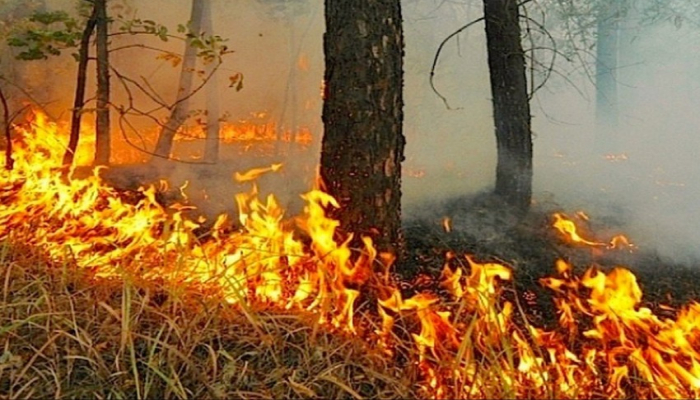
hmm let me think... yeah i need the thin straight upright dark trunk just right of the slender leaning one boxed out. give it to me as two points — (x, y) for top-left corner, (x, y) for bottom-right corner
(94, 0), (111, 165)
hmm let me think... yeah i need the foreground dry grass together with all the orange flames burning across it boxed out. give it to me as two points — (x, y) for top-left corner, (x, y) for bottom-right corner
(0, 113), (700, 398)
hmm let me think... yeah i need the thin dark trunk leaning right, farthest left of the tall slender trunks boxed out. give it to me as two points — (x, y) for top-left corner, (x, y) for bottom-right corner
(63, 8), (97, 167)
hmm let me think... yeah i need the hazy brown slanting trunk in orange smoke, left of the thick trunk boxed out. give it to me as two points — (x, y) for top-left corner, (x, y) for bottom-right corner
(151, 0), (204, 163)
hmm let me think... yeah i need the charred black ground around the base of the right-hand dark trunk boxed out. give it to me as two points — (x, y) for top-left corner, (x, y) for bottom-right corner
(404, 194), (700, 324)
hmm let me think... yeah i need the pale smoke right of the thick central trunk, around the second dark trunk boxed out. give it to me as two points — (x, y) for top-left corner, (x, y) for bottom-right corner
(404, 1), (700, 263)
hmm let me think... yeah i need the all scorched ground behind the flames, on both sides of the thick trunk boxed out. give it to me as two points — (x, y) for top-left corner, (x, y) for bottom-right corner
(89, 159), (700, 325)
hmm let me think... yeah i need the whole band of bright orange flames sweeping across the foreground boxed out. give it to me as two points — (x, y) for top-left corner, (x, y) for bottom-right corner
(0, 115), (700, 398)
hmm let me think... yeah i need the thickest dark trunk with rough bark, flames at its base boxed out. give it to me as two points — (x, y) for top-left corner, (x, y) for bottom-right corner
(320, 0), (405, 255)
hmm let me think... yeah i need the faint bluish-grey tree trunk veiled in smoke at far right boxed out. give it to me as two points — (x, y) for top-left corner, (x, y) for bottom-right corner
(595, 0), (622, 153)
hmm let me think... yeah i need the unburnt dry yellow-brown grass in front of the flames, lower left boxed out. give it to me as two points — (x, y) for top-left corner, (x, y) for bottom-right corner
(0, 244), (416, 399)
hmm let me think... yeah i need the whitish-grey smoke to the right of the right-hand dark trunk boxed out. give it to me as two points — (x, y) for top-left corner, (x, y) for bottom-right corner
(534, 9), (700, 262)
